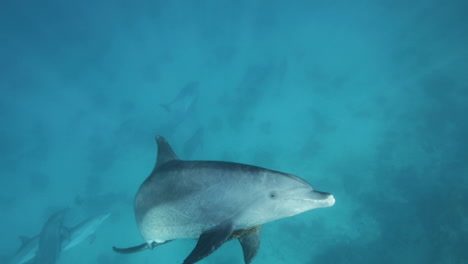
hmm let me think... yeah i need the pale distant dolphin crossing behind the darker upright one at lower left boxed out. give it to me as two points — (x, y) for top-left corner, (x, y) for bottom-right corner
(8, 213), (110, 264)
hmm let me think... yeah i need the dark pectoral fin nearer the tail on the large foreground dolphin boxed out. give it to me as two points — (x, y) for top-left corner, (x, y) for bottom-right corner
(184, 222), (233, 264)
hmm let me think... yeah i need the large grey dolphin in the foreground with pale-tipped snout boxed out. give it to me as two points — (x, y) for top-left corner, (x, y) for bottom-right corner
(113, 136), (335, 264)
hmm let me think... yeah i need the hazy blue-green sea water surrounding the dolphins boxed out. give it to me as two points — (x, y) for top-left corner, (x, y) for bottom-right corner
(0, 0), (468, 264)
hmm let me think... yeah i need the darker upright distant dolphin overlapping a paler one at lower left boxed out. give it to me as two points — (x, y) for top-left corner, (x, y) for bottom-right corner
(33, 210), (67, 264)
